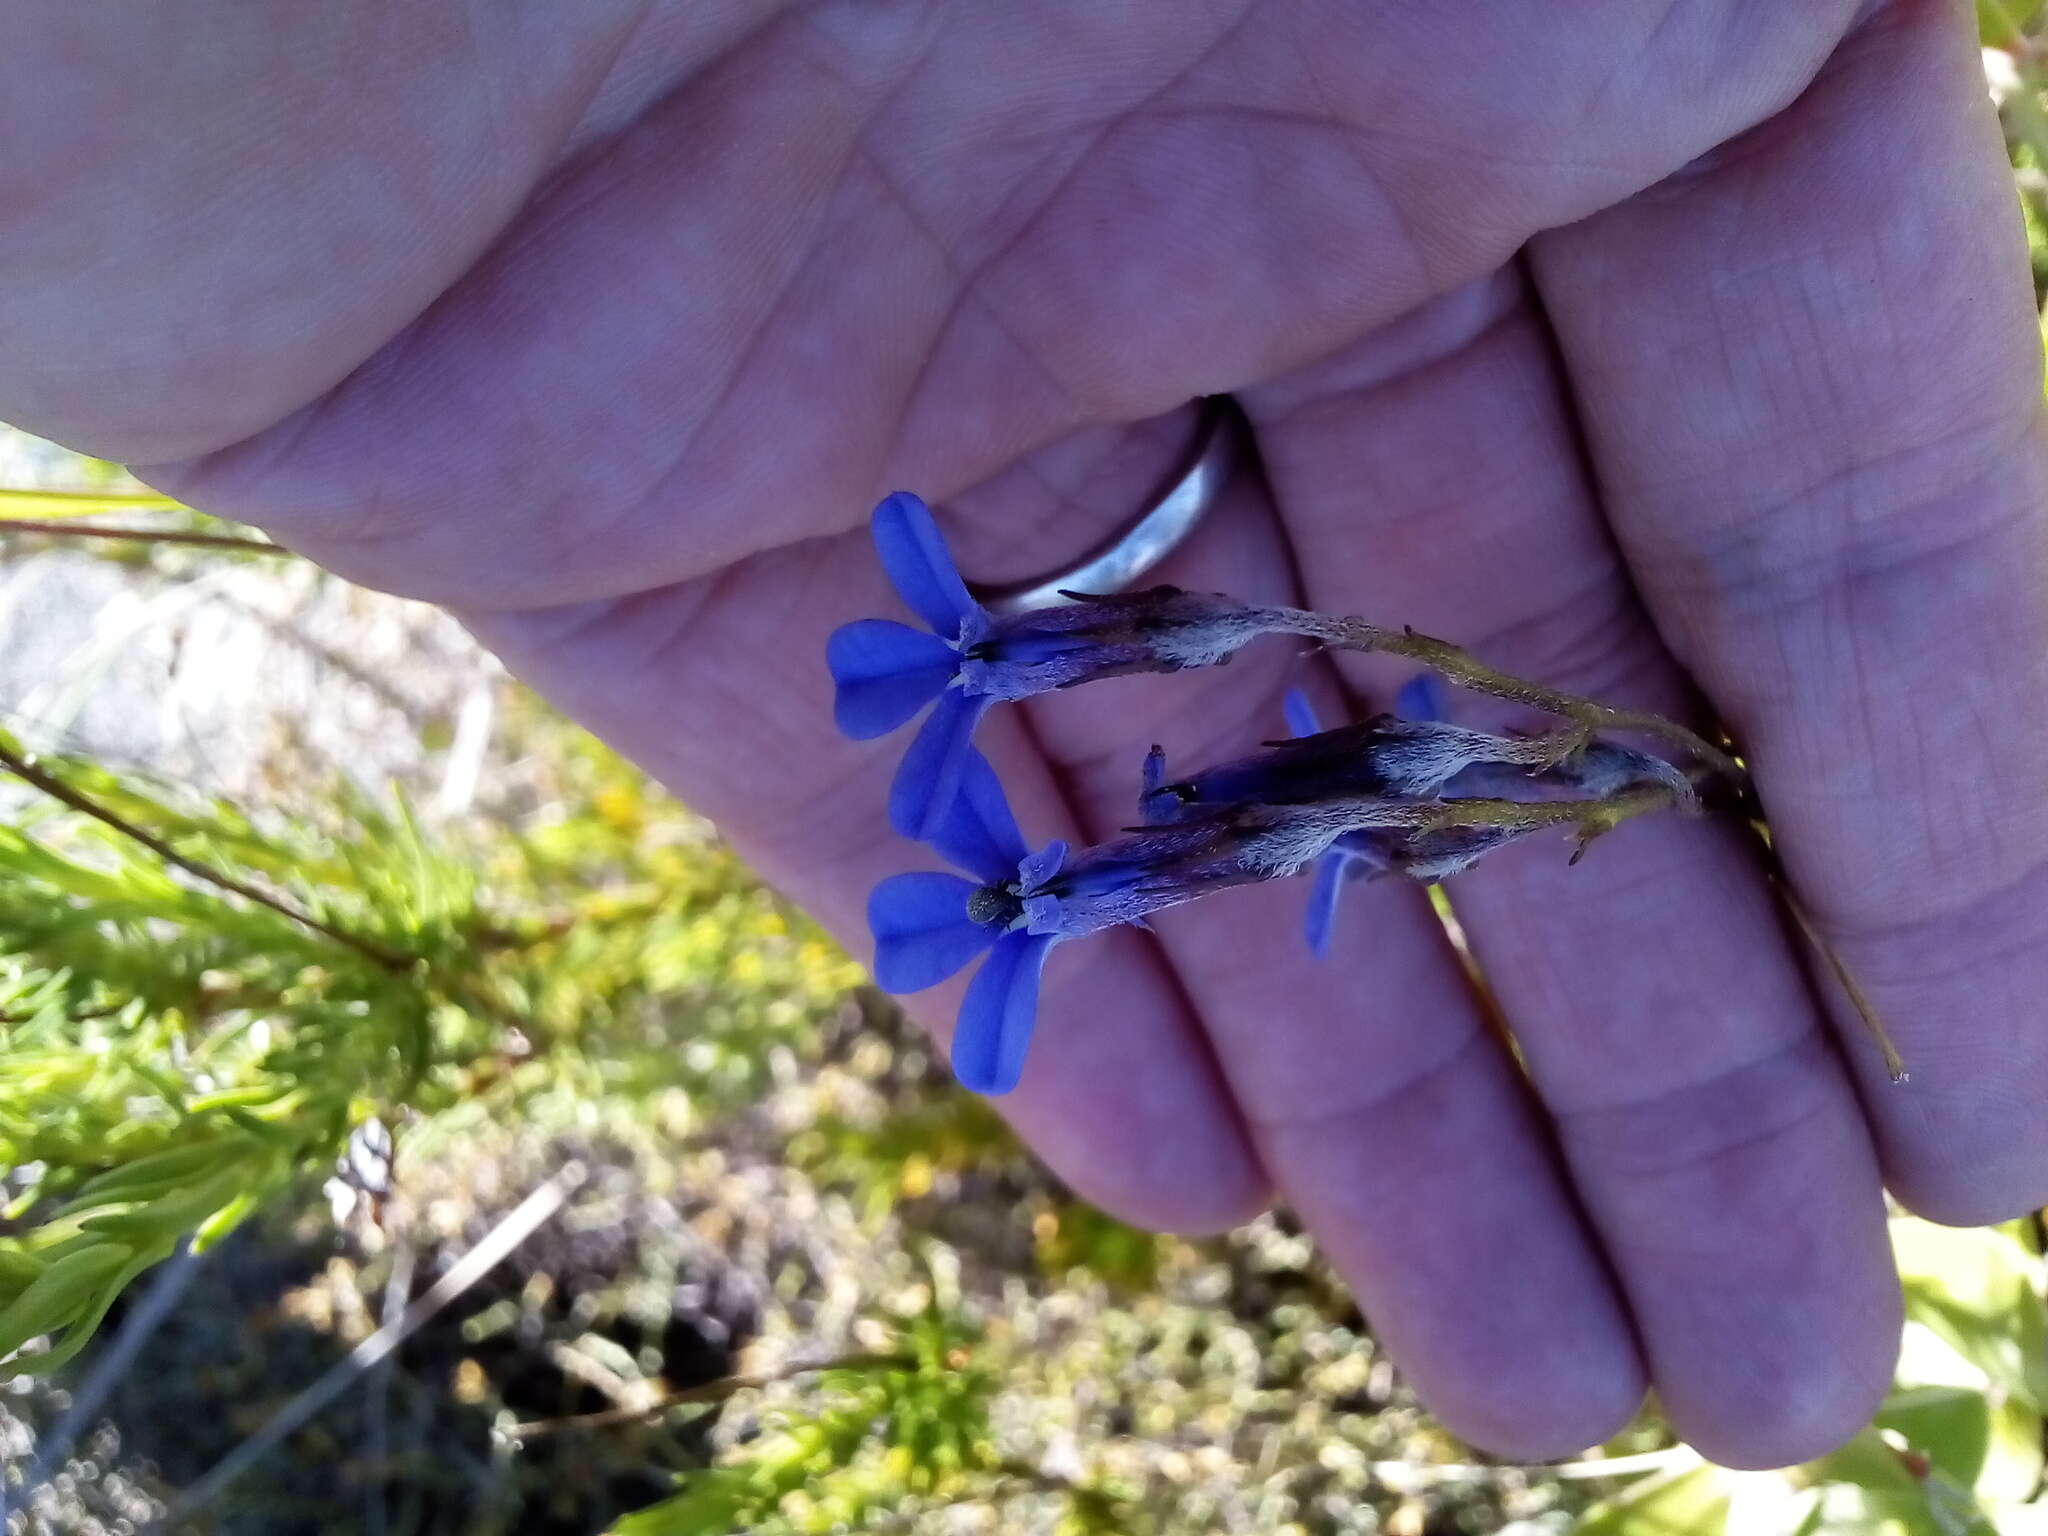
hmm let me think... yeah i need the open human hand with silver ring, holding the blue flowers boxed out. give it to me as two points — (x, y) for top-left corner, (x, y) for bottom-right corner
(0, 0), (2048, 1464)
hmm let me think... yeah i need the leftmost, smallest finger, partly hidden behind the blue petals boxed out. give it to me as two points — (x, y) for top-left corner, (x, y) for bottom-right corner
(469, 481), (1266, 1231)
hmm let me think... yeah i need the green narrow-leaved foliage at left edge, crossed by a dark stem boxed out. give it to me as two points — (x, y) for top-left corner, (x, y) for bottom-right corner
(0, 735), (485, 1374)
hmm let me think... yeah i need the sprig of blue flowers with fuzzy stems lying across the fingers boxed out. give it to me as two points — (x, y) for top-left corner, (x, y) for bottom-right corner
(825, 492), (1903, 1094)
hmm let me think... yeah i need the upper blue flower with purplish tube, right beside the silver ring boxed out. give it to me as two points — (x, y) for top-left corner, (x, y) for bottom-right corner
(825, 492), (1264, 840)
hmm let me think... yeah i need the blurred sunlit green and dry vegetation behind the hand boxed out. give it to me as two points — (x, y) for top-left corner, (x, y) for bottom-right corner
(0, 15), (2048, 1536)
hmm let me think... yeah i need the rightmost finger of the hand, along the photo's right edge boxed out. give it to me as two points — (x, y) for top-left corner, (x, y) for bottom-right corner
(1536, 4), (2048, 1223)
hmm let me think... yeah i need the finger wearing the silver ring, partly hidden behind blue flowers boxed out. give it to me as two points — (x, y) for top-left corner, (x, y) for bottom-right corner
(978, 409), (1642, 1456)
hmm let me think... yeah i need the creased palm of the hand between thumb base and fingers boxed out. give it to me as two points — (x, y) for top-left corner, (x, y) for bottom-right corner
(140, 0), (1853, 608)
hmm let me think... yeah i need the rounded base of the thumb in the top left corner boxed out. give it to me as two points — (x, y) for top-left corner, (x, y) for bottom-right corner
(0, 6), (647, 459)
